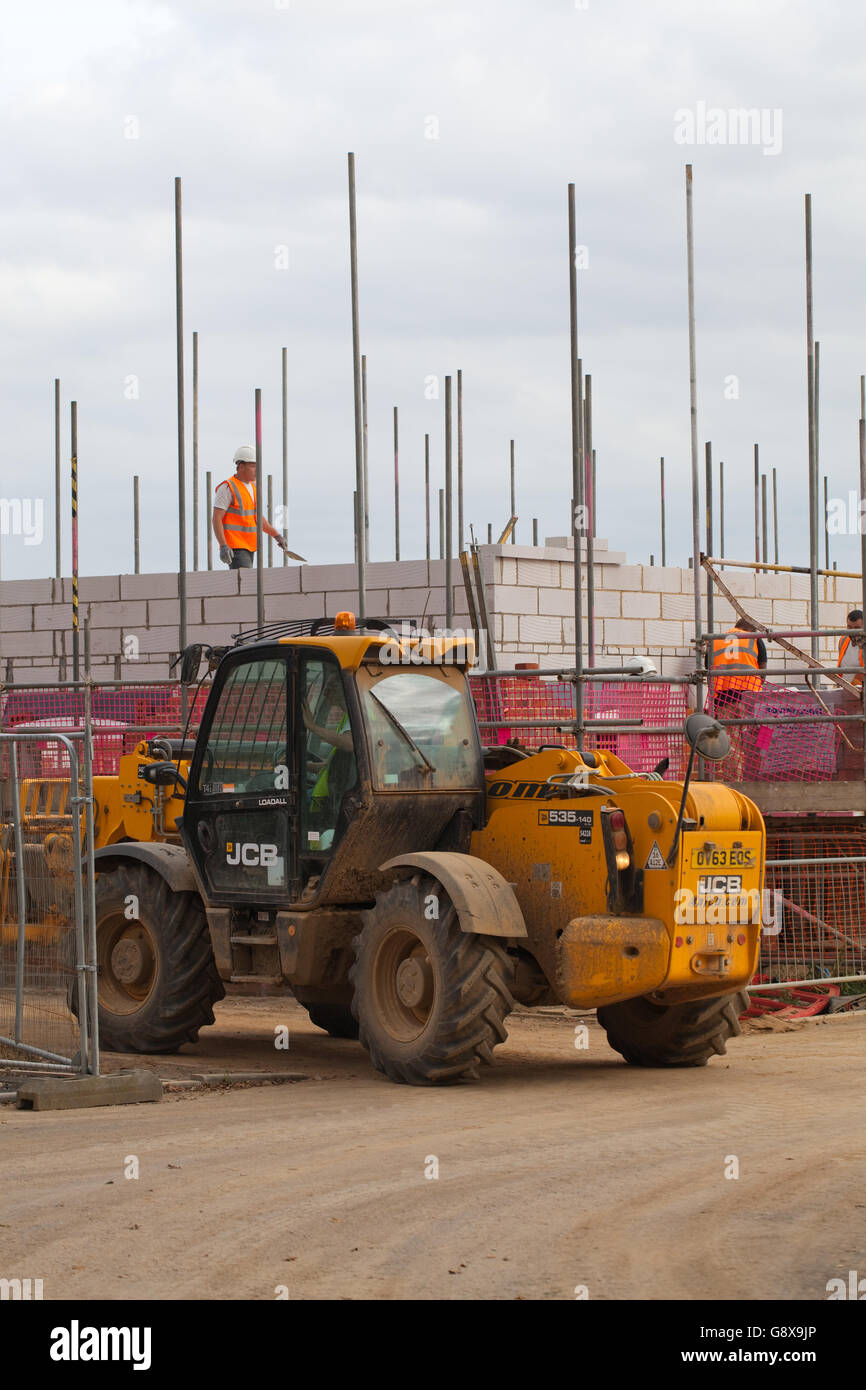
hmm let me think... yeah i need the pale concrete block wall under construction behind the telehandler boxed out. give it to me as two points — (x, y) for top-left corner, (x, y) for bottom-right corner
(0, 537), (862, 682)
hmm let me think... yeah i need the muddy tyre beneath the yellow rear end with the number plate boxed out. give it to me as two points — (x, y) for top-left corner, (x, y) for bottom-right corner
(598, 994), (748, 1066)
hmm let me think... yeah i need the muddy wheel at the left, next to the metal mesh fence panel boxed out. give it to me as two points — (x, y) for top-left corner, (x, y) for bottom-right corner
(70, 863), (225, 1052)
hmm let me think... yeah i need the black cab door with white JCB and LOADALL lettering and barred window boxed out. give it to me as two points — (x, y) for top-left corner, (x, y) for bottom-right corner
(182, 649), (297, 908)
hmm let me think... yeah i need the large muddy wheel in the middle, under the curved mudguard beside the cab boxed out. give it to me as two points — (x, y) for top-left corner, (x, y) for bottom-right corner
(350, 876), (514, 1086)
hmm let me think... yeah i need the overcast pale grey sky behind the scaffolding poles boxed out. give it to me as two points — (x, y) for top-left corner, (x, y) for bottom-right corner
(0, 0), (866, 578)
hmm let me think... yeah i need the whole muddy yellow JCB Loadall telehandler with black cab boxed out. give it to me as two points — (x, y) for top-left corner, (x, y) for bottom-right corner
(13, 614), (765, 1084)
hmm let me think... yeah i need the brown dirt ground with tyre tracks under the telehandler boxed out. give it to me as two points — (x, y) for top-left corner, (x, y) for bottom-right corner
(0, 998), (866, 1300)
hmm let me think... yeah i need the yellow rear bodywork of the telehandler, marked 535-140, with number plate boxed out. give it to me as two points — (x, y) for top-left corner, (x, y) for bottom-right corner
(470, 749), (765, 1008)
